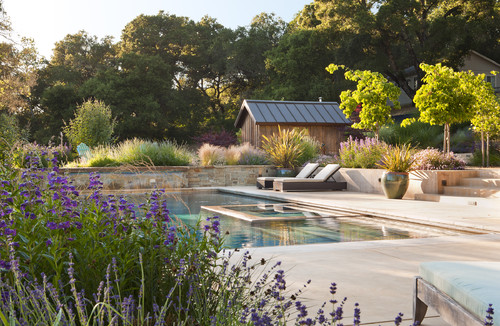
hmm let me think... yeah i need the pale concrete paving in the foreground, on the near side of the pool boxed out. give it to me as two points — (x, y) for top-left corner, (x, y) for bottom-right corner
(240, 234), (500, 325)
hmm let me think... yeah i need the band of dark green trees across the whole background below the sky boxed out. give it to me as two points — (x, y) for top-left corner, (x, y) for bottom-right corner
(0, 0), (500, 143)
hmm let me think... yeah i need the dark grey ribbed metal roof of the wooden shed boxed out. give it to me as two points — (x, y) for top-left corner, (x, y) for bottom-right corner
(234, 100), (351, 128)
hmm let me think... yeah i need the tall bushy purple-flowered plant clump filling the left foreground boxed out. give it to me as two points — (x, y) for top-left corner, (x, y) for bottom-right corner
(0, 153), (222, 318)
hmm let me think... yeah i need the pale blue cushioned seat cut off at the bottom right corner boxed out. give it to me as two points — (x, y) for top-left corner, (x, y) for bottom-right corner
(413, 261), (500, 326)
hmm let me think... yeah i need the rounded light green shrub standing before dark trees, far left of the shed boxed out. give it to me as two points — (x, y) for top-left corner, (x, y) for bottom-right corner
(63, 100), (115, 147)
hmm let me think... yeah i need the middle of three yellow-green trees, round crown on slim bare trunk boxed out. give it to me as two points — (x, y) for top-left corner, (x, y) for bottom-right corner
(402, 63), (478, 153)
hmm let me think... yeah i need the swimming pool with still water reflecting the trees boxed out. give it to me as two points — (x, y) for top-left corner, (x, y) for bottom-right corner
(128, 191), (464, 248)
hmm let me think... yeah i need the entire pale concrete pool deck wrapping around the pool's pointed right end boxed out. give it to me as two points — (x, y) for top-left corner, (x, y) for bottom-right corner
(221, 186), (500, 326)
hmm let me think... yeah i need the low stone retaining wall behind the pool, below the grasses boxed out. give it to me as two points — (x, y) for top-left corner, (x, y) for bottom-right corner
(61, 165), (276, 190)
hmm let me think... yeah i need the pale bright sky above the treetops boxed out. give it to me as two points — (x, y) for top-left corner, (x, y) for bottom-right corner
(3, 0), (312, 58)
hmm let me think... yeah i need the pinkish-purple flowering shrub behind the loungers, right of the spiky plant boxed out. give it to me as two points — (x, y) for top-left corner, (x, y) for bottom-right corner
(338, 137), (388, 169)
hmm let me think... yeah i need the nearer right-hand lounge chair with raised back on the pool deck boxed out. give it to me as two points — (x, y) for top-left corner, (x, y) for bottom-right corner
(273, 164), (347, 192)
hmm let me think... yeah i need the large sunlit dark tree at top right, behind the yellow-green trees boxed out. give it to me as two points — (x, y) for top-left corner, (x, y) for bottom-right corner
(293, 0), (500, 98)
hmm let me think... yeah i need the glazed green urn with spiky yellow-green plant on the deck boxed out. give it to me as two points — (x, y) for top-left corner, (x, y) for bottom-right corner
(377, 144), (415, 199)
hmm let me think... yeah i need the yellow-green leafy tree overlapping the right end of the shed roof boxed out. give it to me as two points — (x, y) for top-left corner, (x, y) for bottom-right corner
(326, 64), (401, 140)
